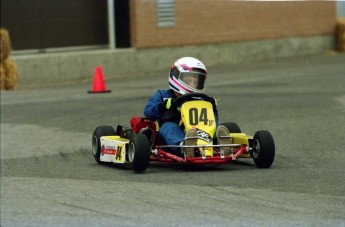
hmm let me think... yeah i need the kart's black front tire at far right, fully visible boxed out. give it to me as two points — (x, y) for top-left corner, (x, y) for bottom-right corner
(251, 130), (275, 168)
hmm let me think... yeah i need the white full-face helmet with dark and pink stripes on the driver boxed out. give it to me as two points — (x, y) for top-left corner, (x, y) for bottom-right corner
(169, 57), (207, 95)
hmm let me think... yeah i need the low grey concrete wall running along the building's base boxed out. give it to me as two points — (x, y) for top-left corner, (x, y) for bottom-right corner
(13, 35), (335, 86)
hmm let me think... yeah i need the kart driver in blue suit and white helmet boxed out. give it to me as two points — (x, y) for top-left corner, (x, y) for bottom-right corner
(144, 57), (230, 157)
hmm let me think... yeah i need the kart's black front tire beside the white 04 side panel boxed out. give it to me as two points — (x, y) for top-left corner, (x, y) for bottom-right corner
(128, 133), (151, 172)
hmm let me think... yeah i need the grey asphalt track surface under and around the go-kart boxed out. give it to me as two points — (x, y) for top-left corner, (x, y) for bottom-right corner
(1, 54), (345, 226)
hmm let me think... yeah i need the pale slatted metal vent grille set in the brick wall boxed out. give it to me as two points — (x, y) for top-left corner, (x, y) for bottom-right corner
(156, 0), (175, 28)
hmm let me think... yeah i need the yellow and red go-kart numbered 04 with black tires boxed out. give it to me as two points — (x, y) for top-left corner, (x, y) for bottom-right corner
(92, 93), (275, 172)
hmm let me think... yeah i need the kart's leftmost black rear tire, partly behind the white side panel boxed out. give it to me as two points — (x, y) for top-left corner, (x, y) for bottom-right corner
(92, 126), (116, 164)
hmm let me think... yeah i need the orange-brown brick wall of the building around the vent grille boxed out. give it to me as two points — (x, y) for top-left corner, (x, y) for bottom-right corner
(130, 0), (336, 48)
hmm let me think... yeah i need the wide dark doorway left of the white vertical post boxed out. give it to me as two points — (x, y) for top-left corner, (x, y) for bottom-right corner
(1, 0), (107, 50)
